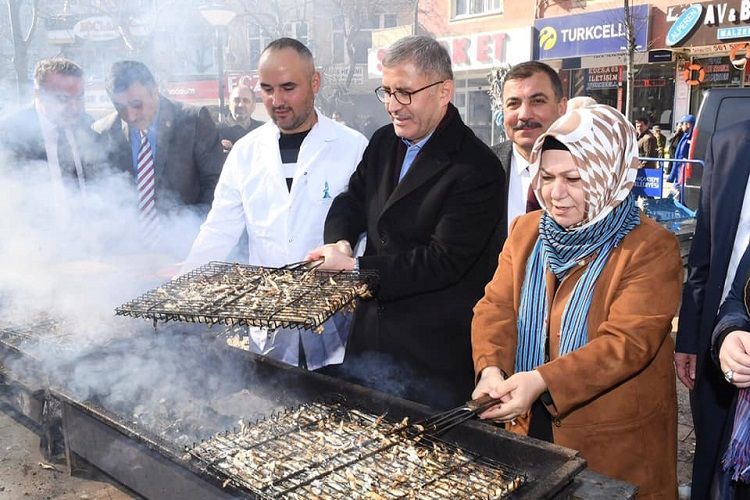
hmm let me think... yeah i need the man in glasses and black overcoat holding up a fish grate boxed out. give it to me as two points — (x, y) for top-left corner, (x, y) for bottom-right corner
(310, 36), (505, 407)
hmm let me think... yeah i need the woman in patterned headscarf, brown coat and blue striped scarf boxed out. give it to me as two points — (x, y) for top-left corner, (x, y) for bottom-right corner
(472, 105), (682, 498)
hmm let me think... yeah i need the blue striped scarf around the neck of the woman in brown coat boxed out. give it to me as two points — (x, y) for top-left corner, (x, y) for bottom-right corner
(515, 194), (640, 373)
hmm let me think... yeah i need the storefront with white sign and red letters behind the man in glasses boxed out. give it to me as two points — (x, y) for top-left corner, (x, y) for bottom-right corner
(368, 27), (533, 144)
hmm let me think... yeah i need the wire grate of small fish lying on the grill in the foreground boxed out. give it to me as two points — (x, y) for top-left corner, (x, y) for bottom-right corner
(188, 403), (526, 500)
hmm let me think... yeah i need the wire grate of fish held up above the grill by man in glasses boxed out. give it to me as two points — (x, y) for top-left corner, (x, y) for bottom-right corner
(115, 262), (376, 330)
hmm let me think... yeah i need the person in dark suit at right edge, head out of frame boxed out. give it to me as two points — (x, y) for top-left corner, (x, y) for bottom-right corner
(675, 121), (750, 499)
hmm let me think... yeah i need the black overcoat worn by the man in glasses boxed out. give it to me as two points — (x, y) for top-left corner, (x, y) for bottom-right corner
(325, 105), (505, 406)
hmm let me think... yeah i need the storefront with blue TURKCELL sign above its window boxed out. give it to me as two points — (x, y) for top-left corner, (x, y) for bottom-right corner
(535, 5), (675, 123)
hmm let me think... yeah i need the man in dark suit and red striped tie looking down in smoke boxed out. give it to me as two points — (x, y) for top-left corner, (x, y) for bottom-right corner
(93, 61), (224, 211)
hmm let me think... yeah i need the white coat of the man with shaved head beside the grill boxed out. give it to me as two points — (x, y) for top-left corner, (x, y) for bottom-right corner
(181, 110), (367, 370)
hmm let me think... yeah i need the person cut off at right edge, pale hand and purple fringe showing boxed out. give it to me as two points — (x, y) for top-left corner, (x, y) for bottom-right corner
(712, 246), (750, 500)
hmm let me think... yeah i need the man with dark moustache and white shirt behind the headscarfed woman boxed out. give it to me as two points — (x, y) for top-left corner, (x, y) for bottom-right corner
(492, 61), (566, 240)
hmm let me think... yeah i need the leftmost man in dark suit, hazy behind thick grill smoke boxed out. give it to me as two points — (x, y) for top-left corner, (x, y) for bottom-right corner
(0, 58), (102, 201)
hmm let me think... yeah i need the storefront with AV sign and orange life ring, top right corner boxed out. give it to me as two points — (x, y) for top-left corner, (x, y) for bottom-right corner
(655, 0), (750, 115)
